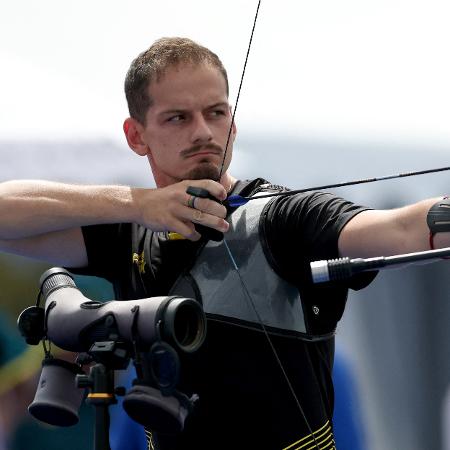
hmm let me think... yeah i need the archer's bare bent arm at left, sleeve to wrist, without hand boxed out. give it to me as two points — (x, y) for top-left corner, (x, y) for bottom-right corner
(0, 180), (142, 267)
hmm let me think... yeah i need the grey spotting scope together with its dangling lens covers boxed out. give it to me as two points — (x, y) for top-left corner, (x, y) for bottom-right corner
(18, 268), (206, 433)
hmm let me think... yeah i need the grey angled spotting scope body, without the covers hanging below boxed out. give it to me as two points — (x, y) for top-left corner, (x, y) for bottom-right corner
(40, 268), (206, 353)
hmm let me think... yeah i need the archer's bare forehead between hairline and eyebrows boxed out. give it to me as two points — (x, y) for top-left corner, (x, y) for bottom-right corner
(148, 63), (228, 109)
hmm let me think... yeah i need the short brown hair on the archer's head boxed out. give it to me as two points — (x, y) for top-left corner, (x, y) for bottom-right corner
(125, 37), (229, 124)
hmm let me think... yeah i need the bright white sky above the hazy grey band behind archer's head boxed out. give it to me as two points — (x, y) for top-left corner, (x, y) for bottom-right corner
(0, 0), (450, 147)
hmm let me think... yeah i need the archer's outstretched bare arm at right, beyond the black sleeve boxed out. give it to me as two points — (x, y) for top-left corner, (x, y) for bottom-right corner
(339, 197), (450, 258)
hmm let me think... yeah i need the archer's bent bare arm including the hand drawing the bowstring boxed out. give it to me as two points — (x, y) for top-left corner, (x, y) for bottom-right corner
(0, 180), (228, 267)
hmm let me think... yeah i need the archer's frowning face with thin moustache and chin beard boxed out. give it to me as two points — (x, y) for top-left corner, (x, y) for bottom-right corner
(142, 64), (236, 187)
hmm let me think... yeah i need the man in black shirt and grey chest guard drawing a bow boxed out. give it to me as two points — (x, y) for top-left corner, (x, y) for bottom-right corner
(0, 38), (450, 449)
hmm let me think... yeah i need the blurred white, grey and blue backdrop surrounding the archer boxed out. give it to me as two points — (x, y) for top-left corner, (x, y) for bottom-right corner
(0, 0), (450, 450)
